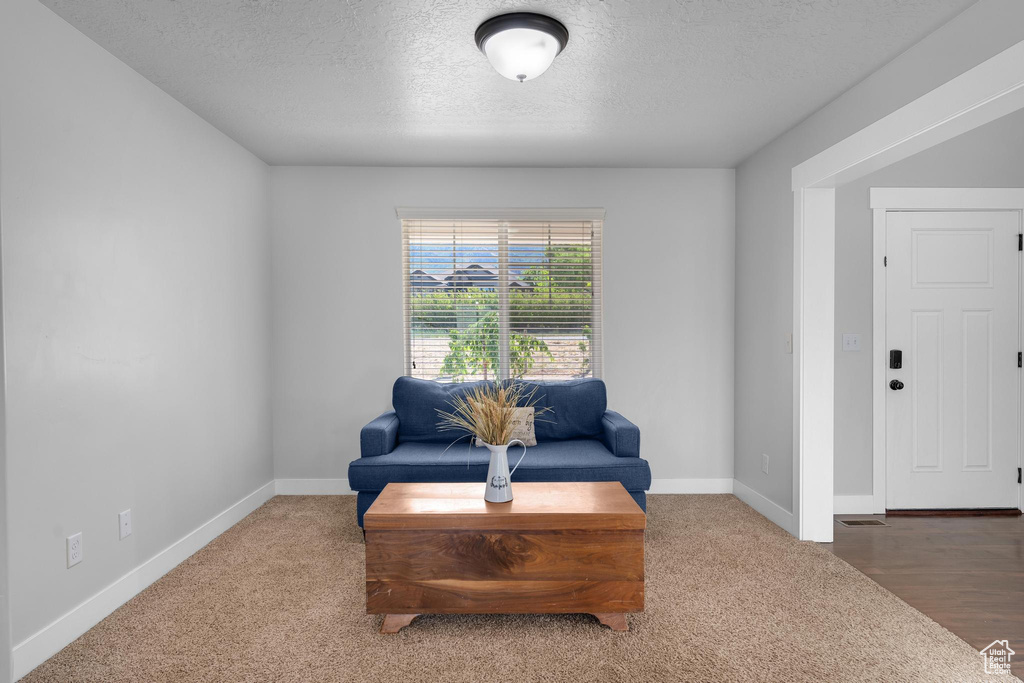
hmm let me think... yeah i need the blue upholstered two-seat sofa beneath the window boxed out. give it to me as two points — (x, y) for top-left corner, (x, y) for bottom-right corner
(348, 377), (650, 526)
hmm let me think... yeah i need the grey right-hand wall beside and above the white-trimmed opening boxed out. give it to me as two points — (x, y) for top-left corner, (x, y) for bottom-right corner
(735, 0), (1024, 510)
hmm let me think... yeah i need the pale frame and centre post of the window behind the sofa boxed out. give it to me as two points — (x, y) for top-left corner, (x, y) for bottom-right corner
(395, 207), (605, 382)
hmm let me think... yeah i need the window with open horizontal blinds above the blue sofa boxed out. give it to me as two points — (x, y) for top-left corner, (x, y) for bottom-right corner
(398, 209), (604, 382)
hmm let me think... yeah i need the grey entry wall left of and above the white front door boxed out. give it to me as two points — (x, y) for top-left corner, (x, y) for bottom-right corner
(836, 111), (1024, 496)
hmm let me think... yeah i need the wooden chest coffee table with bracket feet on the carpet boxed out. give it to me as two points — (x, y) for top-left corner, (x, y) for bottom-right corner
(364, 482), (647, 633)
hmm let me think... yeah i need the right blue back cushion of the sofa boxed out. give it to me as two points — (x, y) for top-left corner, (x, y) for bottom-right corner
(523, 377), (608, 441)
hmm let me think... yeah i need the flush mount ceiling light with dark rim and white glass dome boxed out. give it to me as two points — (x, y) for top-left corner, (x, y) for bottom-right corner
(476, 12), (569, 83)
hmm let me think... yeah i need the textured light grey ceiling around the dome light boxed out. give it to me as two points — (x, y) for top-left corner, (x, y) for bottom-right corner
(43, 0), (973, 167)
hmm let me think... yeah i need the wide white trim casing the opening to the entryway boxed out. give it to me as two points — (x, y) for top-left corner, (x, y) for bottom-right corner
(792, 41), (1024, 543)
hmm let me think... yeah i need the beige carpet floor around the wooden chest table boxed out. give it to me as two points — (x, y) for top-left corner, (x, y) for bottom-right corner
(24, 496), (1010, 683)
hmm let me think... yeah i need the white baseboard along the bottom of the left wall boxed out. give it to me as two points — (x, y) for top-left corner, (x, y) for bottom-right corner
(11, 480), (274, 681)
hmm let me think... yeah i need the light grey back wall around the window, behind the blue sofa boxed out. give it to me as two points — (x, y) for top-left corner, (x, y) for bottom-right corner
(270, 167), (735, 479)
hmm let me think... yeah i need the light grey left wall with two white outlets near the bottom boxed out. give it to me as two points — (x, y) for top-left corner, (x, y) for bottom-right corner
(0, 0), (272, 655)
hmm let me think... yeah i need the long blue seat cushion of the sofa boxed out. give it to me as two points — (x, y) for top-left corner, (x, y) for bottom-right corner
(348, 439), (650, 492)
